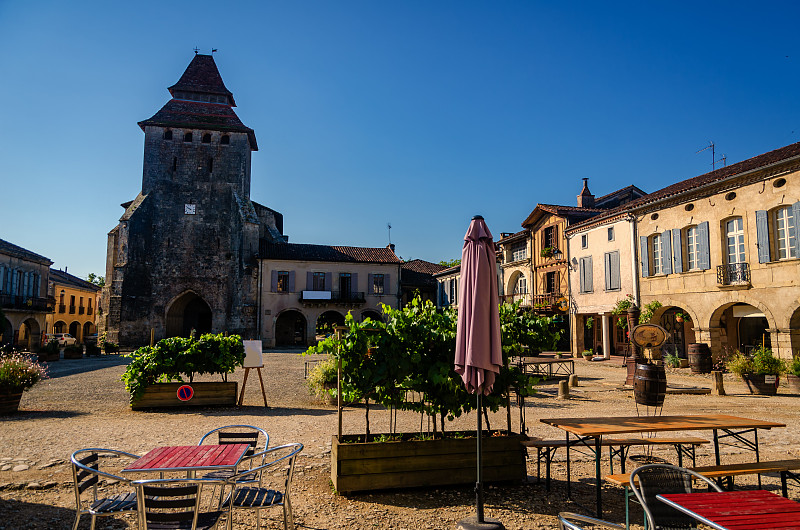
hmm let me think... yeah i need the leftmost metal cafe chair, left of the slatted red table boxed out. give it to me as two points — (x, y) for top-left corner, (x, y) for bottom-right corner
(70, 448), (139, 530)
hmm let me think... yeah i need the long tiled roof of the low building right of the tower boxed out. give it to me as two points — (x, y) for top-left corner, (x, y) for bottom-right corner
(259, 239), (400, 263)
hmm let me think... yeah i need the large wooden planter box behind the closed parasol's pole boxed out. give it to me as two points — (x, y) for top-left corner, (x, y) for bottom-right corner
(331, 434), (527, 493)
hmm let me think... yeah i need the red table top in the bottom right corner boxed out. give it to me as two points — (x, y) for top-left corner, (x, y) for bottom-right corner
(659, 490), (800, 530)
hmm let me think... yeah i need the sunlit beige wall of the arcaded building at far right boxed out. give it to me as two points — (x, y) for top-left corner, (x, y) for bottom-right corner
(637, 169), (800, 358)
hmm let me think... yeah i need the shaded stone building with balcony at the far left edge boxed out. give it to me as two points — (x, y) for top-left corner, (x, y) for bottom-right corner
(0, 239), (53, 351)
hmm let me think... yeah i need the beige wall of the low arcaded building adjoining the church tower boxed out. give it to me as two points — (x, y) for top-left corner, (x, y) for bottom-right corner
(260, 259), (400, 348)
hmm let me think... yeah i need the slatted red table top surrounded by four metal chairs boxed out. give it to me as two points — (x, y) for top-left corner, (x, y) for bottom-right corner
(122, 444), (250, 472)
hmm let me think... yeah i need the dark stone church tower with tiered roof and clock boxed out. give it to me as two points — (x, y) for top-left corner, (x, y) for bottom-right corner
(101, 55), (285, 347)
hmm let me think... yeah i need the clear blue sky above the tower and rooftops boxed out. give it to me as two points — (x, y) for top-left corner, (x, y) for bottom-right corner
(0, 0), (800, 277)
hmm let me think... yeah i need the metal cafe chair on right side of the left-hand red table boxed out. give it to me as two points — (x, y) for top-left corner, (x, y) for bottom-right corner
(222, 443), (303, 530)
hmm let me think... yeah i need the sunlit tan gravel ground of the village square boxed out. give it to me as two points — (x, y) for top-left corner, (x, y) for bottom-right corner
(0, 351), (800, 530)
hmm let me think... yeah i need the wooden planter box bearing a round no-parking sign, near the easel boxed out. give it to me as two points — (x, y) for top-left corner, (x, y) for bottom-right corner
(131, 381), (238, 410)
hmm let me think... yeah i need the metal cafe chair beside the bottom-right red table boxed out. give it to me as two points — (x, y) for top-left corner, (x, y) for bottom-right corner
(630, 464), (722, 530)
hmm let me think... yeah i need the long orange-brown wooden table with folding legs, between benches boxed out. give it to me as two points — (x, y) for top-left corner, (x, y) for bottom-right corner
(540, 414), (786, 519)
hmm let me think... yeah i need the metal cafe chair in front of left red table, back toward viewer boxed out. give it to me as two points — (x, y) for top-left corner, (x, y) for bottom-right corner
(133, 478), (225, 530)
